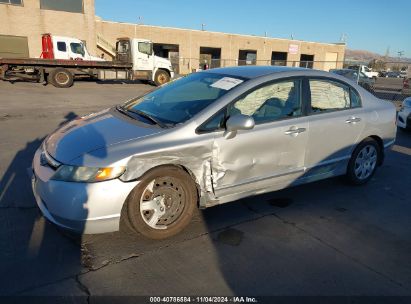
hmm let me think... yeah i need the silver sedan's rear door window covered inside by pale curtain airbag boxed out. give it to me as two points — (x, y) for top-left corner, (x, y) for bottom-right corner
(309, 79), (351, 113)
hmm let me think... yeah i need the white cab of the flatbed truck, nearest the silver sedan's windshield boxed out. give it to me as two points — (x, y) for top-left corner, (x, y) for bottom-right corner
(116, 38), (174, 85)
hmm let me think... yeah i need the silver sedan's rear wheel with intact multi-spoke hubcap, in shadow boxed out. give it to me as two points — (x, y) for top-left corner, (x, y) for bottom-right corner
(346, 138), (382, 185)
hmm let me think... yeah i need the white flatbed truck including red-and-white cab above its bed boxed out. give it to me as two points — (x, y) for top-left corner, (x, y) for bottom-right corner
(0, 34), (174, 88)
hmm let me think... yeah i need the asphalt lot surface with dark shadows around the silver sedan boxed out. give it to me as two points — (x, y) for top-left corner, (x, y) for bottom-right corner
(0, 82), (411, 302)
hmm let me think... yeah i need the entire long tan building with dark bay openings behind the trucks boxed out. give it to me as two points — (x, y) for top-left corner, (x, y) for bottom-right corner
(0, 0), (345, 74)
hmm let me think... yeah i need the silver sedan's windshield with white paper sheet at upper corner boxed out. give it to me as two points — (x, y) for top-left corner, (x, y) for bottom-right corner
(123, 72), (244, 125)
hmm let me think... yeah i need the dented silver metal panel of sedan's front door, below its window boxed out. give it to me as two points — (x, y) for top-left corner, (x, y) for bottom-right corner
(212, 117), (309, 198)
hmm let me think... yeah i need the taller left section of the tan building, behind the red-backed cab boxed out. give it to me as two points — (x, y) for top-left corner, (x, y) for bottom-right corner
(0, 0), (96, 57)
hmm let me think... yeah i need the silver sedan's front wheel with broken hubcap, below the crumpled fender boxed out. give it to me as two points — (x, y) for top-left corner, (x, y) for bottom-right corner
(127, 166), (198, 240)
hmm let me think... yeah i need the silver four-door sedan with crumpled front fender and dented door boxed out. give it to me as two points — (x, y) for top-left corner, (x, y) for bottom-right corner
(32, 66), (396, 239)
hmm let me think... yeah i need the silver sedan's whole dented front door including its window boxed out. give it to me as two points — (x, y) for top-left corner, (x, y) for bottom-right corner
(212, 78), (308, 199)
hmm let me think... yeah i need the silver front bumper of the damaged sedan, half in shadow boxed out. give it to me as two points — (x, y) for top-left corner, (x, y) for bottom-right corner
(32, 150), (138, 234)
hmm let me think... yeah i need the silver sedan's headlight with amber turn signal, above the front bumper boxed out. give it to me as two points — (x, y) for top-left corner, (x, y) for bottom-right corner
(51, 165), (126, 183)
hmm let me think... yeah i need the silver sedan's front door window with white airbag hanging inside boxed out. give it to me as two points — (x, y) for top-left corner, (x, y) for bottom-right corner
(228, 80), (302, 124)
